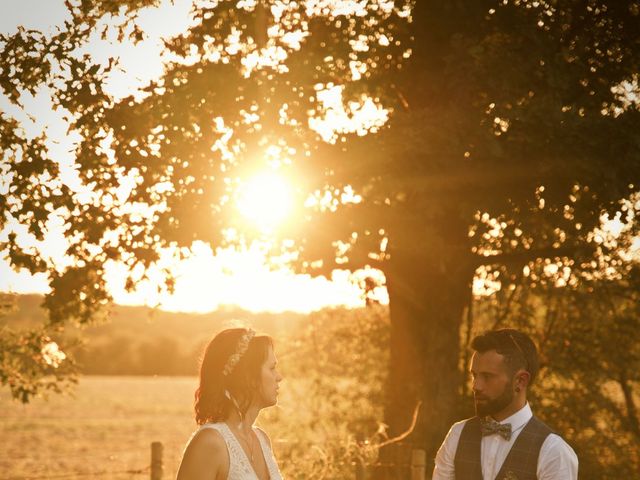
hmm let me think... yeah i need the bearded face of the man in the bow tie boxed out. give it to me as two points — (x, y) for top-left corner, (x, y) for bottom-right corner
(471, 350), (514, 417)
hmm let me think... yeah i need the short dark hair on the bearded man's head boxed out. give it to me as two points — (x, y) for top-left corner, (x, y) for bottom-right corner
(471, 328), (540, 385)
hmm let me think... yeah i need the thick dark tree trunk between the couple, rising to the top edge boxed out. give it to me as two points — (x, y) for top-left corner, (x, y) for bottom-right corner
(382, 0), (502, 469)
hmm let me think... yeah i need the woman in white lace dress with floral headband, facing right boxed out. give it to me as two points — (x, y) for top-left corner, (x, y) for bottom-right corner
(177, 328), (282, 480)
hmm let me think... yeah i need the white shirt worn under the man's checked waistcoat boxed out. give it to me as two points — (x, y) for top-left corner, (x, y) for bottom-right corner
(432, 403), (578, 480)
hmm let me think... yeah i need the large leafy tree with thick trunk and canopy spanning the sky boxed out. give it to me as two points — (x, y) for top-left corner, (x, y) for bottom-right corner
(0, 0), (640, 464)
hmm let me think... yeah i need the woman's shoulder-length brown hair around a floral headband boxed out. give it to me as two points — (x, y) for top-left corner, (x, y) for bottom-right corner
(194, 328), (273, 425)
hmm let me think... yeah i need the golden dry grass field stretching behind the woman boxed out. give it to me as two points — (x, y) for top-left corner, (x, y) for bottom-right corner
(0, 376), (348, 480)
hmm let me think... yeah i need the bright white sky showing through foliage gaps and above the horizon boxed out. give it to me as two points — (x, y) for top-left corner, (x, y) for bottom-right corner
(0, 0), (387, 312)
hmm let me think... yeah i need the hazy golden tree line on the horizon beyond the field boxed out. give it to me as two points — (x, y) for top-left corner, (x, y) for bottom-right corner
(0, 294), (307, 382)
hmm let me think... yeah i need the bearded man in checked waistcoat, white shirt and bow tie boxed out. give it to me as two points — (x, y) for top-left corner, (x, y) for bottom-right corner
(432, 329), (578, 480)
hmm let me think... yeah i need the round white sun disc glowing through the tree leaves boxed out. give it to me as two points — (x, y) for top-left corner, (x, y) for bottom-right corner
(237, 172), (293, 232)
